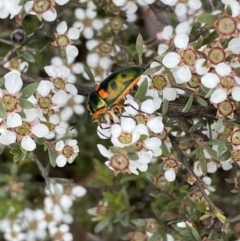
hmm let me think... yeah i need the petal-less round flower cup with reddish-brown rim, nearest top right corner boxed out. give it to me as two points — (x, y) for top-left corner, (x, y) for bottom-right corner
(214, 13), (238, 38)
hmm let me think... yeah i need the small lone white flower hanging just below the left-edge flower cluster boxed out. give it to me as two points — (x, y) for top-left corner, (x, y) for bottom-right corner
(55, 139), (79, 167)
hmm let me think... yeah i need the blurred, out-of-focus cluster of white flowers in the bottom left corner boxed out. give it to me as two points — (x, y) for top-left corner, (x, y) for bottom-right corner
(0, 184), (86, 241)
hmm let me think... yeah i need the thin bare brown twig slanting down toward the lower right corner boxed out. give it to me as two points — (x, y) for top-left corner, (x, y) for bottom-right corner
(168, 133), (218, 211)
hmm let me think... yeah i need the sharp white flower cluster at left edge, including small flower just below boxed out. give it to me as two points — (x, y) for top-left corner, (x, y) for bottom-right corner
(0, 66), (80, 169)
